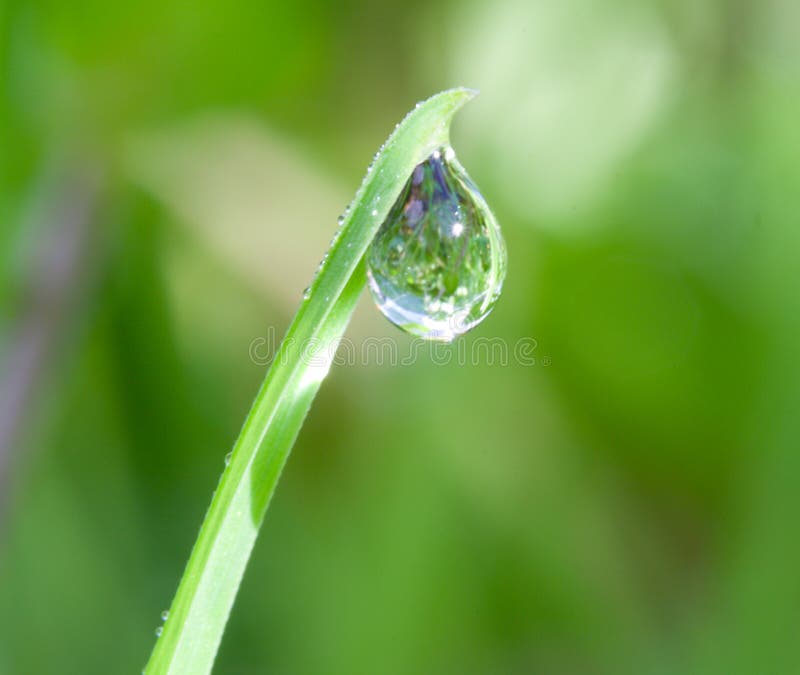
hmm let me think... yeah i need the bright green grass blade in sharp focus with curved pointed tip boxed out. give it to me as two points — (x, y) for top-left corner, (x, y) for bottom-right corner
(145, 89), (475, 675)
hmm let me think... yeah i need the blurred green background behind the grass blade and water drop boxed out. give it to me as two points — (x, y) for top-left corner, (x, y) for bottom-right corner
(0, 0), (800, 675)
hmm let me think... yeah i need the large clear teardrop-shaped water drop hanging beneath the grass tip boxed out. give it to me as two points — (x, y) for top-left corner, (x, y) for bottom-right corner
(367, 148), (506, 342)
